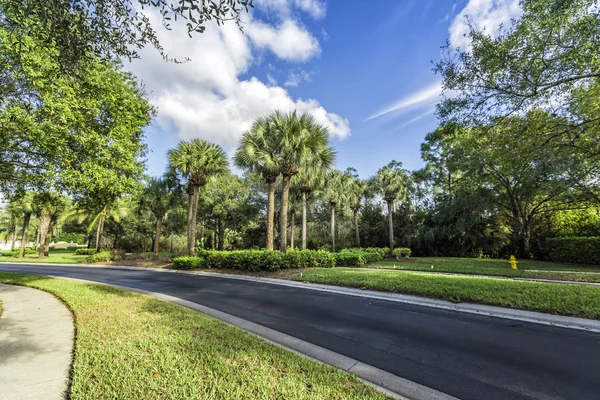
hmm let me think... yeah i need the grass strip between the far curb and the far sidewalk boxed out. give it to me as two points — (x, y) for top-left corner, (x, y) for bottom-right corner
(292, 268), (600, 319)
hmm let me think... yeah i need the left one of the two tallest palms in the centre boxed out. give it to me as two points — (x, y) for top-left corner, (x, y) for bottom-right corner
(233, 118), (279, 250)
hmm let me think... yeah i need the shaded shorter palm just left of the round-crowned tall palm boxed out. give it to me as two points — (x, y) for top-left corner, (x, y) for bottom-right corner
(139, 177), (176, 253)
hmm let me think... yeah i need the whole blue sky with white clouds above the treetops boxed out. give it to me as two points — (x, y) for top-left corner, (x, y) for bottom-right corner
(135, 0), (519, 177)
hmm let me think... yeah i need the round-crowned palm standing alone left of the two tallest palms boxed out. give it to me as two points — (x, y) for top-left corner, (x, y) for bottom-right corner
(168, 139), (227, 255)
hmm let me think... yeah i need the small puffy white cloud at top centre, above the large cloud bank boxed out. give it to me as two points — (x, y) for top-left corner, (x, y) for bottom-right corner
(244, 19), (321, 61)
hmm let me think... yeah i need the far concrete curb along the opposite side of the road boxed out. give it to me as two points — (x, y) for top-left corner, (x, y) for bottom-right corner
(0, 263), (600, 333)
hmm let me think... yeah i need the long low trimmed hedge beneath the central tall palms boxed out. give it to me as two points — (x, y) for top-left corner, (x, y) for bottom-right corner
(173, 250), (336, 271)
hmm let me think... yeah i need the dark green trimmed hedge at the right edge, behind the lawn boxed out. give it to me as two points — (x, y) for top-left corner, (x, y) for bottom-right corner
(546, 236), (600, 265)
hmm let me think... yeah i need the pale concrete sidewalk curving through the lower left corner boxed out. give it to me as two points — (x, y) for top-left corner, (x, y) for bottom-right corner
(0, 284), (74, 400)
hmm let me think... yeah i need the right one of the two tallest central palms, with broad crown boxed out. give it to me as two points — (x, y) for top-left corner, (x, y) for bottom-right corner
(270, 111), (335, 253)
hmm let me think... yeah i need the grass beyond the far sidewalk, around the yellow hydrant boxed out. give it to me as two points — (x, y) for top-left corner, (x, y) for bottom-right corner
(368, 257), (600, 283)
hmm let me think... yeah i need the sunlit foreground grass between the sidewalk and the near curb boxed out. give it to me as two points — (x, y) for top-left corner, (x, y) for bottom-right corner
(0, 273), (385, 400)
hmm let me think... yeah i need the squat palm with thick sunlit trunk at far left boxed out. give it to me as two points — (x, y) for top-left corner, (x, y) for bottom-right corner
(33, 191), (70, 258)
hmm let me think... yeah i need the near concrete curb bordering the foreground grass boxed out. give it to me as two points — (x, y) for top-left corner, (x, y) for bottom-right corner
(57, 275), (459, 400)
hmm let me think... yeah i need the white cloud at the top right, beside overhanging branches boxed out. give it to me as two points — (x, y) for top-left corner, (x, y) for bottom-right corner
(450, 0), (522, 50)
